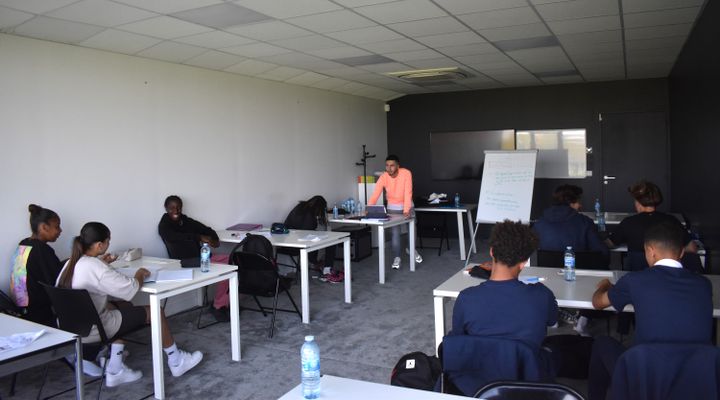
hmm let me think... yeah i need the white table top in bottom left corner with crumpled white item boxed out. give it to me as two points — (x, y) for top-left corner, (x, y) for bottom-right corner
(0, 314), (77, 363)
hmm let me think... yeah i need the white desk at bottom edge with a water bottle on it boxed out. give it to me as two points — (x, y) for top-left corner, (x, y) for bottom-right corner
(278, 375), (468, 400)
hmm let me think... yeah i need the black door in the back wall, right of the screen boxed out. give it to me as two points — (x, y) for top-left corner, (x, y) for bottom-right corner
(600, 112), (670, 212)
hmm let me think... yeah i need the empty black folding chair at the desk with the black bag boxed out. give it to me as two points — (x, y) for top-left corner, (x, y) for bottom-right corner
(230, 251), (302, 338)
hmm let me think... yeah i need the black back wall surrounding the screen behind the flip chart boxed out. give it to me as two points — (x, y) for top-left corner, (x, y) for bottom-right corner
(388, 79), (668, 222)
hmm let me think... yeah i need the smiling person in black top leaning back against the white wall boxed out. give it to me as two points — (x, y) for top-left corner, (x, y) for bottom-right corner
(158, 195), (230, 322)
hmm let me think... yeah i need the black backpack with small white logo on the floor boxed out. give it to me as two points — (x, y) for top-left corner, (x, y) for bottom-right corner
(390, 351), (442, 391)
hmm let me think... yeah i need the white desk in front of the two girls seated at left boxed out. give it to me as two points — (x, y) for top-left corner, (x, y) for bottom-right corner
(113, 257), (240, 399)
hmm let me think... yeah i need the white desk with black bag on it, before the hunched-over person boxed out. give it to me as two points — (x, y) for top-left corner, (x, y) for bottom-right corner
(218, 229), (352, 324)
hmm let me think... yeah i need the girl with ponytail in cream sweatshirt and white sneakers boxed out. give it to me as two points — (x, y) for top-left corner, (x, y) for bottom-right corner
(57, 222), (203, 387)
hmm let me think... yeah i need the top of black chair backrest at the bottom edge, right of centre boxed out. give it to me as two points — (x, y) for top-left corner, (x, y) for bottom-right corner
(473, 381), (585, 400)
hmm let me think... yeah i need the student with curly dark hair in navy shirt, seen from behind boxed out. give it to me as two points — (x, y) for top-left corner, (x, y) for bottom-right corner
(449, 220), (558, 348)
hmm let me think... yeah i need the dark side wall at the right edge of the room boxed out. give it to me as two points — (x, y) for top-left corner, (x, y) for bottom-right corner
(669, 1), (720, 269)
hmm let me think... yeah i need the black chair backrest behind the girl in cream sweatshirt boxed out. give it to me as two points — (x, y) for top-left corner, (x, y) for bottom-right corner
(40, 283), (108, 343)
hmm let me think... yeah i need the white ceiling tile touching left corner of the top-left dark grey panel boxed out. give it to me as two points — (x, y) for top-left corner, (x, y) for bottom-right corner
(46, 0), (158, 27)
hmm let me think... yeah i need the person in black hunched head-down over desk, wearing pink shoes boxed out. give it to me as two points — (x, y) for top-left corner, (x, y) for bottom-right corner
(285, 196), (343, 283)
